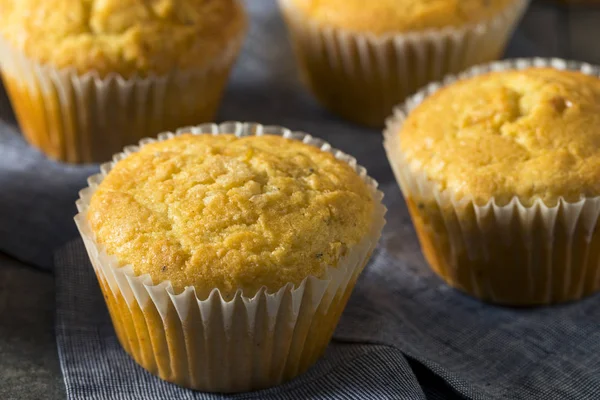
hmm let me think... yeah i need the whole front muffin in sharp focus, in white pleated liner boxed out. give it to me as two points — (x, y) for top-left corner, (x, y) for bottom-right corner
(76, 123), (385, 392)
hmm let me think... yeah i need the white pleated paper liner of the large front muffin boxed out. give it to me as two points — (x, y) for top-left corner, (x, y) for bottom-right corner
(75, 122), (386, 392)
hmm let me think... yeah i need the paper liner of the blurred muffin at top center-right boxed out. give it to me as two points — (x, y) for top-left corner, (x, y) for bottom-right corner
(279, 0), (529, 127)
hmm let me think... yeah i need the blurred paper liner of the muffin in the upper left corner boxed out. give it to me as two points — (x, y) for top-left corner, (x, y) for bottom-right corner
(0, 27), (244, 163)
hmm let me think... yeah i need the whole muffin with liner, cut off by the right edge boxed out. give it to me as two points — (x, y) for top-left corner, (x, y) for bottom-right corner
(385, 59), (600, 306)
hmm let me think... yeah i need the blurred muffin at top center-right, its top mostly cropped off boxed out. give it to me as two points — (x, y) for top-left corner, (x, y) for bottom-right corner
(279, 0), (528, 127)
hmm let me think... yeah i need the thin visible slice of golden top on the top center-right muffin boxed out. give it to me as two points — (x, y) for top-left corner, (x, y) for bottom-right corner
(291, 0), (520, 35)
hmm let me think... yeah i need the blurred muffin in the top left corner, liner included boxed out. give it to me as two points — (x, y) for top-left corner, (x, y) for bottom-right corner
(0, 0), (246, 163)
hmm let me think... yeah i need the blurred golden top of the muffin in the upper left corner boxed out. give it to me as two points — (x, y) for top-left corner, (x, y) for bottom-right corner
(0, 0), (246, 77)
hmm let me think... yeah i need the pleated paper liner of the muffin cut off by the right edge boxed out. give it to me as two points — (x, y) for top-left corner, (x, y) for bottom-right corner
(384, 58), (600, 305)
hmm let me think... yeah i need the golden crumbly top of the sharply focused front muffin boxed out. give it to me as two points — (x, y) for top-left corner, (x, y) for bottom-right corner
(88, 134), (374, 296)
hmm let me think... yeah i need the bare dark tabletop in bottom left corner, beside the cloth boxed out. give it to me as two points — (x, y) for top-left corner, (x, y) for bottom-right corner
(0, 254), (65, 400)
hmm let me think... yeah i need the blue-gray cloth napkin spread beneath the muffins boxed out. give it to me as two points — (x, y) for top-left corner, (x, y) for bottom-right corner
(0, 0), (600, 400)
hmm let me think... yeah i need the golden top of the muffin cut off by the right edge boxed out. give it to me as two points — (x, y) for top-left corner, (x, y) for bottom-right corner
(400, 68), (600, 205)
